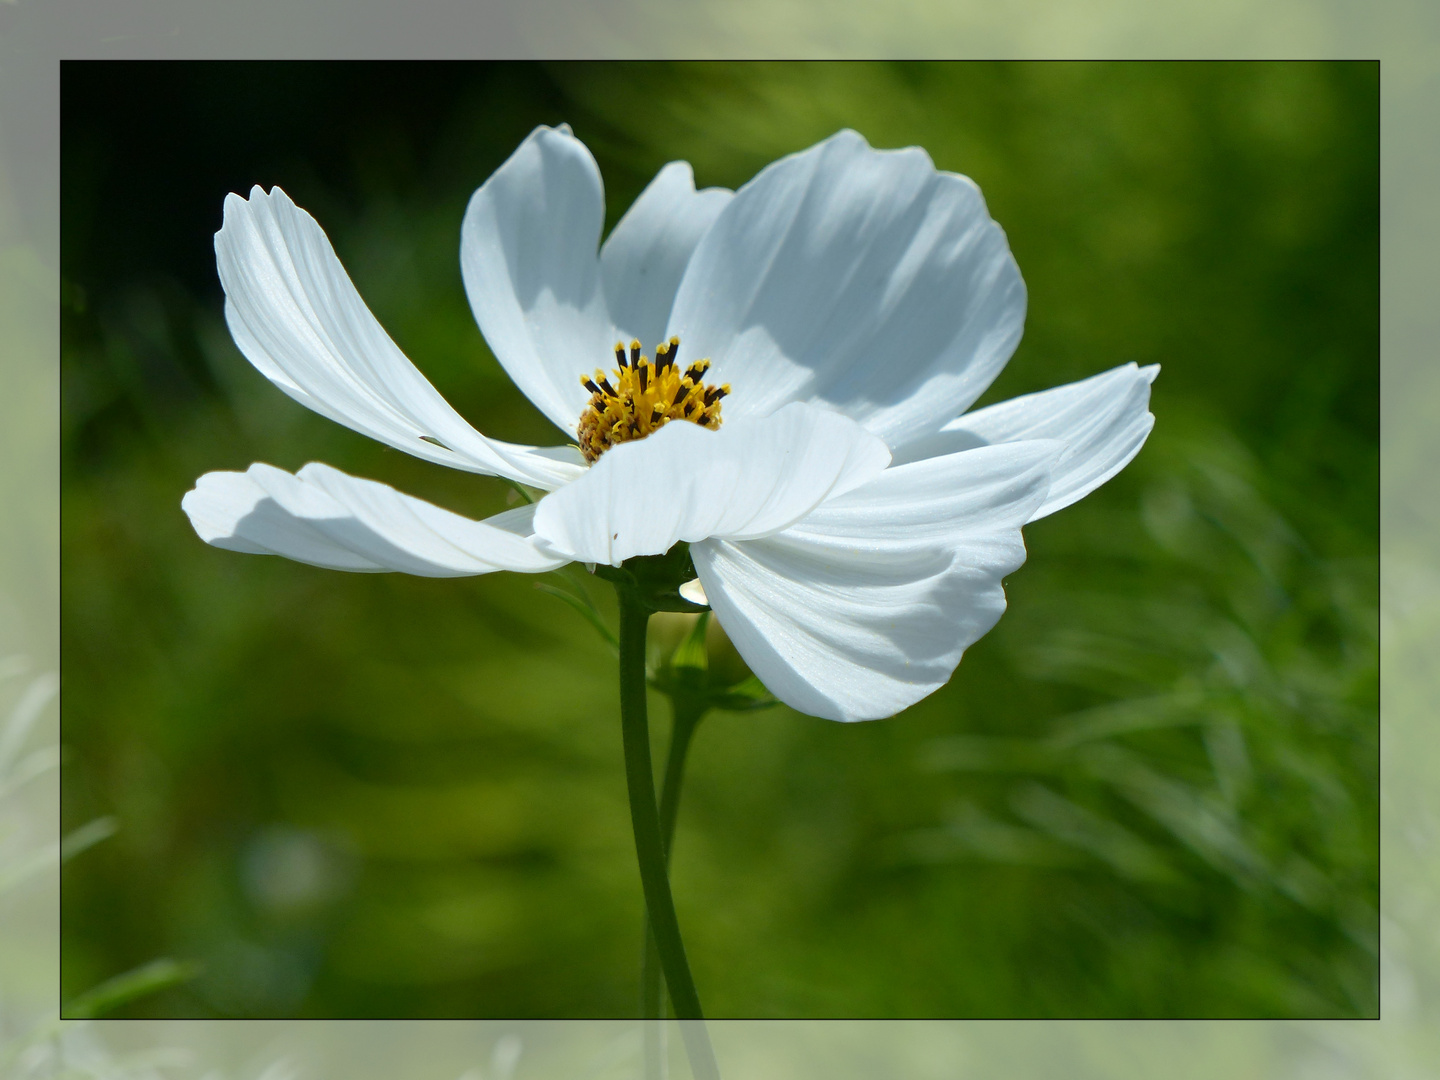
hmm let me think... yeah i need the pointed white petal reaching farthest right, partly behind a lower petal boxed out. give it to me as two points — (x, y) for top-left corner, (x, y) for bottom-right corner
(896, 364), (1161, 520)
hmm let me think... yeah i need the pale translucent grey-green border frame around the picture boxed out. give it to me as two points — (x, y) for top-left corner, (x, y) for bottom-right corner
(8, 0), (1440, 1080)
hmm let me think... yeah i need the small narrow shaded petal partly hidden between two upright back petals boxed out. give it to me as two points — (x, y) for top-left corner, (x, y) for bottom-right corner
(600, 161), (734, 351)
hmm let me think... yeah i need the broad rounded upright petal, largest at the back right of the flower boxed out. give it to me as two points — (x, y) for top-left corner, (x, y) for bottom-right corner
(670, 131), (1025, 446)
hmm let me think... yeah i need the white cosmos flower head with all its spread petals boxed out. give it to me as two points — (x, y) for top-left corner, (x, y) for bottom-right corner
(183, 127), (1158, 720)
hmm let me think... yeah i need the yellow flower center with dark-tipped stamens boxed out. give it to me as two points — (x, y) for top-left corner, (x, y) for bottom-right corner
(576, 337), (730, 464)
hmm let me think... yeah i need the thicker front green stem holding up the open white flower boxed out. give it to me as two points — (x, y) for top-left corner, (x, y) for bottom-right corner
(615, 586), (720, 1080)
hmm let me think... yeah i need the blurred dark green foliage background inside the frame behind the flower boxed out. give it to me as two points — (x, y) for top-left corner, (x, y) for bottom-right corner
(62, 63), (1380, 1017)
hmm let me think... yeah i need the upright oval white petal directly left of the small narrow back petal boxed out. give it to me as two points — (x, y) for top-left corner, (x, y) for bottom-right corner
(459, 127), (616, 436)
